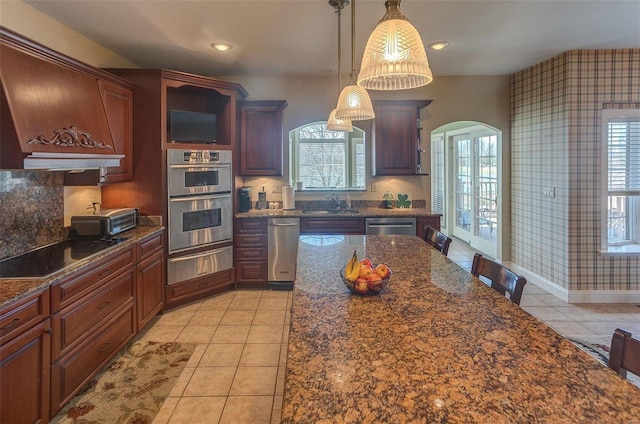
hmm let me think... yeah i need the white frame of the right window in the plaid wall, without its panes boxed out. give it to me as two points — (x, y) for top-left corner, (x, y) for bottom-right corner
(601, 109), (640, 256)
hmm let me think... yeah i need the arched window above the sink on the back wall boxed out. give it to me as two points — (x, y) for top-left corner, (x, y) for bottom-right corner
(289, 122), (365, 190)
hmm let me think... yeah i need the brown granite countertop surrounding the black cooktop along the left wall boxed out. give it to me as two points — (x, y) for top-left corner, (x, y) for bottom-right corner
(0, 226), (164, 307)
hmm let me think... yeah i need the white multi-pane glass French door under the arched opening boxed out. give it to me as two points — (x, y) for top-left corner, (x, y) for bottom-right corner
(453, 132), (499, 257)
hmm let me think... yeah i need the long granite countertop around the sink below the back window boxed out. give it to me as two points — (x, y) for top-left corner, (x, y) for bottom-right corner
(235, 208), (440, 218)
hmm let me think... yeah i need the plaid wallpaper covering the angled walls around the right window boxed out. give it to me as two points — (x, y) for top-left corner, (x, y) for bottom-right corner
(511, 49), (640, 292)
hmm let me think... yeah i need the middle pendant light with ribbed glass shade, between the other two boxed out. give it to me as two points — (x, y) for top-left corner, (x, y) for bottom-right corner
(336, 0), (376, 121)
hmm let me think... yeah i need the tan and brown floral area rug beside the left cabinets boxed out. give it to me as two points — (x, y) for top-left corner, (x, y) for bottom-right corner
(50, 342), (196, 424)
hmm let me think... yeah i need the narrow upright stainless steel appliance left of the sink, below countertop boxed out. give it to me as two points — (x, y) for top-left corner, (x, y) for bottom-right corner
(267, 218), (300, 290)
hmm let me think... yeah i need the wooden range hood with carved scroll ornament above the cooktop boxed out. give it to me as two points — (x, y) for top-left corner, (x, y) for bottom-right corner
(0, 27), (132, 176)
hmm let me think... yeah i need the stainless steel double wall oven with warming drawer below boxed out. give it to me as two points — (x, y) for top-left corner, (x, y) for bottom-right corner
(167, 149), (233, 284)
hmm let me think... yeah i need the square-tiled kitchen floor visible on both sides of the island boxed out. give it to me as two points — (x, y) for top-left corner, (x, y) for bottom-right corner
(139, 240), (640, 424)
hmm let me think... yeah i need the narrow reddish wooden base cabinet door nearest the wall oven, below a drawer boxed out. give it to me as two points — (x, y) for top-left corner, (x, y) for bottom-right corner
(136, 250), (164, 331)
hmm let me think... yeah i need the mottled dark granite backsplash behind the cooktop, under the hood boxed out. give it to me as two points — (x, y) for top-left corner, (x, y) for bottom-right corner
(0, 170), (65, 259)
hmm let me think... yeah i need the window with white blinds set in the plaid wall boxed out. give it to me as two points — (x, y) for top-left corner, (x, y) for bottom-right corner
(602, 109), (640, 254)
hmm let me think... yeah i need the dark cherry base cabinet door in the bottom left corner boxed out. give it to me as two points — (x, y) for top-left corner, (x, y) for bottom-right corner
(0, 319), (51, 423)
